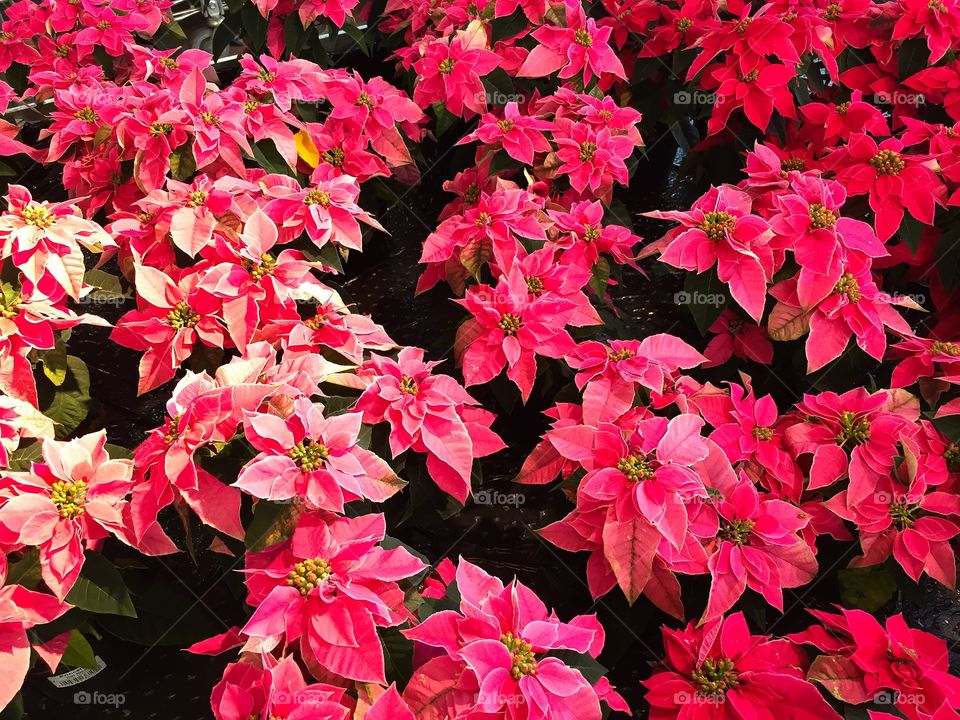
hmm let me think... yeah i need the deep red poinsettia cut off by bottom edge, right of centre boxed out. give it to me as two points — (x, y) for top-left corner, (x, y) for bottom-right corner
(643, 612), (840, 720)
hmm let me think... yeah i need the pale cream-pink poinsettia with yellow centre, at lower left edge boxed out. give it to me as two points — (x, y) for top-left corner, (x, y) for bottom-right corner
(0, 431), (133, 599)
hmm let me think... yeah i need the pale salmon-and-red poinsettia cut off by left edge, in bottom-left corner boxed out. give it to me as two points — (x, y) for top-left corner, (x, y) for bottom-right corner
(0, 554), (70, 707)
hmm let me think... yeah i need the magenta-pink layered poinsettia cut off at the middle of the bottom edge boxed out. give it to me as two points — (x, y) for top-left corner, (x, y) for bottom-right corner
(404, 558), (619, 720)
